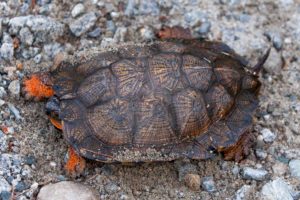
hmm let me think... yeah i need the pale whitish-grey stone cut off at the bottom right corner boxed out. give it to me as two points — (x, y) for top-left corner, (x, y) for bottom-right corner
(261, 178), (293, 200)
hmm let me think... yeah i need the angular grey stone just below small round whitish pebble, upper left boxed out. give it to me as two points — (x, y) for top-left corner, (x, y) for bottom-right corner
(69, 12), (97, 37)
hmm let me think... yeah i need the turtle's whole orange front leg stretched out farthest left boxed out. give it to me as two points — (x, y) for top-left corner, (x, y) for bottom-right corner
(22, 73), (54, 101)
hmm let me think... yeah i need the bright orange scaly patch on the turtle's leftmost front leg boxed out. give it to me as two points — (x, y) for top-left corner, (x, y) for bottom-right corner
(24, 74), (54, 99)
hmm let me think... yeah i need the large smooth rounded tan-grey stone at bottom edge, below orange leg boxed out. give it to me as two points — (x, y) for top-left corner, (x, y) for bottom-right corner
(37, 181), (100, 200)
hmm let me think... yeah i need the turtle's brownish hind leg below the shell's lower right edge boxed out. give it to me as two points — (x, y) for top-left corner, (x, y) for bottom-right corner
(221, 132), (255, 162)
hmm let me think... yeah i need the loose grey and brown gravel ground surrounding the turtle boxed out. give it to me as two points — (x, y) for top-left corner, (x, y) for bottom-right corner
(0, 0), (300, 200)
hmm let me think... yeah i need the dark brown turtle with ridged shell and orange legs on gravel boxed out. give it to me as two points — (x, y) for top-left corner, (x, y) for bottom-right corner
(23, 27), (270, 174)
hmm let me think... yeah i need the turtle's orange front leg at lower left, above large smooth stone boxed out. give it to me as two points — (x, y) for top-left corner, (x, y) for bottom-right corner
(65, 147), (86, 177)
